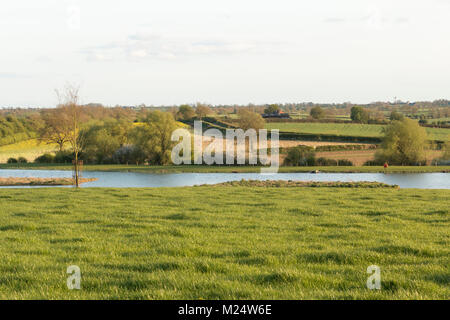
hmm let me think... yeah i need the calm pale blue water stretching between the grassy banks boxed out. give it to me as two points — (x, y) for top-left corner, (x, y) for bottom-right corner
(0, 170), (450, 189)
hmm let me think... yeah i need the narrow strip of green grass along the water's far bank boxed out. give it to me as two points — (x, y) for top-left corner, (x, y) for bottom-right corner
(0, 163), (450, 173)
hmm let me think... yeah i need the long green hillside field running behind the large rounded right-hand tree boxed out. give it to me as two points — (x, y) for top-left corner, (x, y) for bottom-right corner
(266, 122), (450, 140)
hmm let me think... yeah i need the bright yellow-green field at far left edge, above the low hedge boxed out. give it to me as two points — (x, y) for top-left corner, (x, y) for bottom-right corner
(0, 139), (57, 163)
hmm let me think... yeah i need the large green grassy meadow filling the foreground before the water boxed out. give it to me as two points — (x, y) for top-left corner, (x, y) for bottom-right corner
(0, 187), (450, 299)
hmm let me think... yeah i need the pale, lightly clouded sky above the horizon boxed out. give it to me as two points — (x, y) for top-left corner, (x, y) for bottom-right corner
(0, 0), (450, 107)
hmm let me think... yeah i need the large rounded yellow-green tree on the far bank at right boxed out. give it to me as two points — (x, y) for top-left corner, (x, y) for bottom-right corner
(376, 118), (427, 165)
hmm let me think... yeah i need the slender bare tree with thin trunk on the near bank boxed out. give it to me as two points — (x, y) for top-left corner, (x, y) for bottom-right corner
(56, 85), (85, 188)
